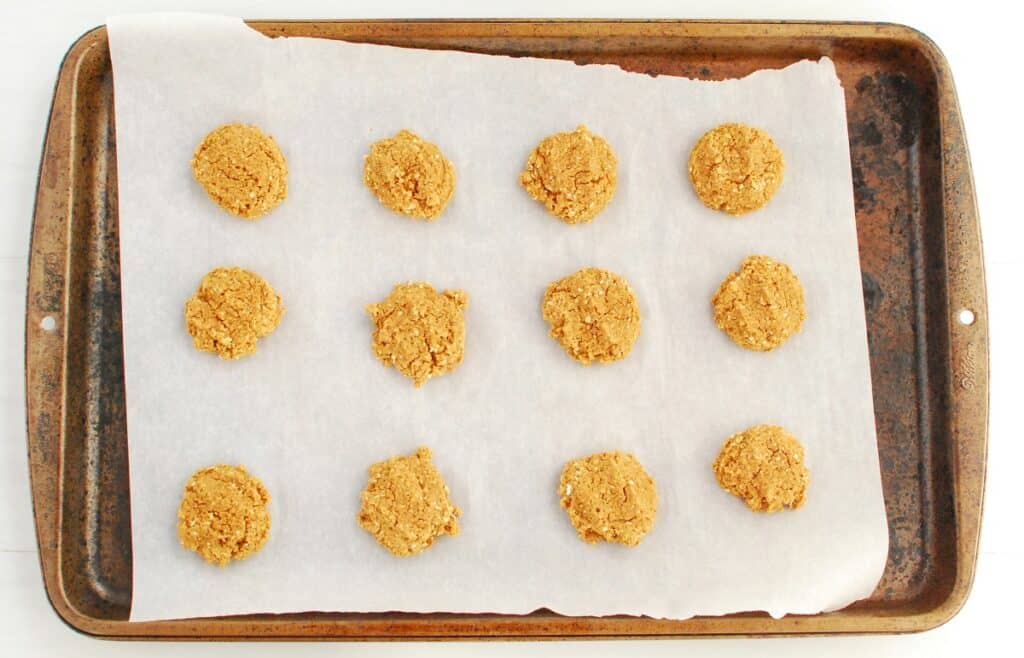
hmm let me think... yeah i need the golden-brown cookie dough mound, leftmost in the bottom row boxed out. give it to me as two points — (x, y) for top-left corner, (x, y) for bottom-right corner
(178, 464), (270, 567)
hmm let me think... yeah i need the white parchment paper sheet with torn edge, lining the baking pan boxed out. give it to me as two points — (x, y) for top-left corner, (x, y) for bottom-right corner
(109, 15), (888, 620)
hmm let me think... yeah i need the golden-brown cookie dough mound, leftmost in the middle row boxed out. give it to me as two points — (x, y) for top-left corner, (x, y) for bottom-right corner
(185, 267), (285, 359)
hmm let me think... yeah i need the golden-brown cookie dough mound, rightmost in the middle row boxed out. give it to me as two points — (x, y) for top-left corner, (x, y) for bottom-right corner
(711, 256), (807, 352)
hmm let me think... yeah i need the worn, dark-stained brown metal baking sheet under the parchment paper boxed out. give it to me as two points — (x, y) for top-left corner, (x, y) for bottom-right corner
(26, 20), (988, 640)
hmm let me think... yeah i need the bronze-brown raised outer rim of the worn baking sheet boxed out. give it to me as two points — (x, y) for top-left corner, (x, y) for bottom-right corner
(26, 20), (988, 640)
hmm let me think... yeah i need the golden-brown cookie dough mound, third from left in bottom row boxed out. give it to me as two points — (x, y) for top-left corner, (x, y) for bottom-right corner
(558, 450), (657, 546)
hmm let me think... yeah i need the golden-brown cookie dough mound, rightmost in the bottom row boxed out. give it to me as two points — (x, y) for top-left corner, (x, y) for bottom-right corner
(712, 425), (810, 512)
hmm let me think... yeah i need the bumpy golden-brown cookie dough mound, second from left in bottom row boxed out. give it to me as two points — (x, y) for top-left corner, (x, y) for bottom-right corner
(357, 447), (462, 557)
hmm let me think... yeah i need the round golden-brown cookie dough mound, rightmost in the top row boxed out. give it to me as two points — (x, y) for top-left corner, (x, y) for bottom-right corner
(689, 124), (785, 215)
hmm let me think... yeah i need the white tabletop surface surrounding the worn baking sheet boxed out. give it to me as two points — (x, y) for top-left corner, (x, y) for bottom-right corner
(0, 0), (1024, 657)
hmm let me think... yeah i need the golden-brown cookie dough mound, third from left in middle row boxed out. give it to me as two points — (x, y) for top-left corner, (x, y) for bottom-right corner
(541, 267), (640, 365)
